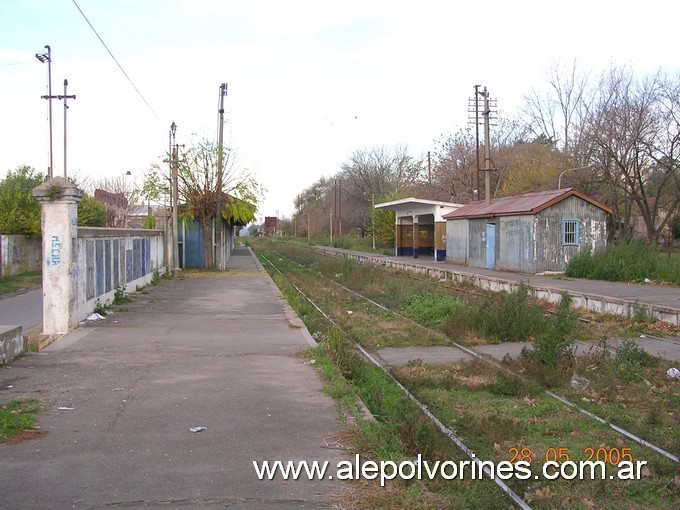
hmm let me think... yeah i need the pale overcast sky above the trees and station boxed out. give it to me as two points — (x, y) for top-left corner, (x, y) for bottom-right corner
(0, 0), (680, 216)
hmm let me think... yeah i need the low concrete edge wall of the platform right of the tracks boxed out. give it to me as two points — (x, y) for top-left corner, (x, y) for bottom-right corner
(315, 246), (680, 326)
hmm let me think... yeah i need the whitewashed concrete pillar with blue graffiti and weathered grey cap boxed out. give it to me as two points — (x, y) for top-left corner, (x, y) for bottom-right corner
(33, 177), (83, 335)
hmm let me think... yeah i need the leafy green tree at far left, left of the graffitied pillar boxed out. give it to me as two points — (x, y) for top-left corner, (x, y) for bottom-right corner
(0, 165), (43, 236)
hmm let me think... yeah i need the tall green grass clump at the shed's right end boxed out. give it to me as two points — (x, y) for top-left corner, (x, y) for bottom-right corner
(566, 241), (680, 285)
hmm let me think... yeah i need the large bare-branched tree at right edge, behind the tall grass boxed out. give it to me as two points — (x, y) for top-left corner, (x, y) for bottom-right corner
(589, 68), (680, 242)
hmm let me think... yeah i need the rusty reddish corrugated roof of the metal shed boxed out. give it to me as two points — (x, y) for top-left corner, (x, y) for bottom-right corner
(444, 188), (611, 220)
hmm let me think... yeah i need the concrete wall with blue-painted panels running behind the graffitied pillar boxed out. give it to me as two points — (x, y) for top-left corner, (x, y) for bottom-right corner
(75, 227), (166, 321)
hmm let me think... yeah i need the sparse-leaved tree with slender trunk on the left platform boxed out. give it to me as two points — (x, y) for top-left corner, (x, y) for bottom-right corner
(142, 141), (264, 268)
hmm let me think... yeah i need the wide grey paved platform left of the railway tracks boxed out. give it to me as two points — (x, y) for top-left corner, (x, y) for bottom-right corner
(0, 250), (346, 509)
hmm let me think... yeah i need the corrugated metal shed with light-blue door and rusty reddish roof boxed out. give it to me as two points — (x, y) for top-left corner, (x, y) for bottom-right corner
(444, 188), (611, 273)
